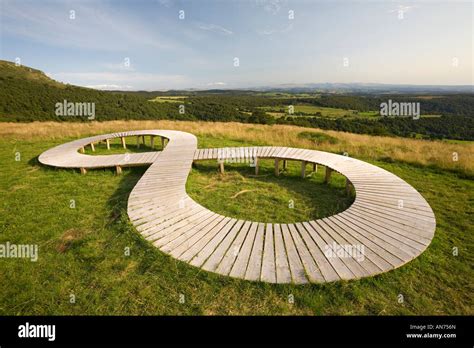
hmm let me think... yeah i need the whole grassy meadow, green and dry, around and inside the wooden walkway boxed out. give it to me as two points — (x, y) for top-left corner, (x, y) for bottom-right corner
(0, 121), (474, 315)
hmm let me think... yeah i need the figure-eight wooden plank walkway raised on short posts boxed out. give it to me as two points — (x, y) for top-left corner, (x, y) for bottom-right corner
(39, 130), (436, 283)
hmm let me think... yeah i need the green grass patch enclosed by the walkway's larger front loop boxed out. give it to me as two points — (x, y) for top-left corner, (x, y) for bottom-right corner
(186, 160), (353, 223)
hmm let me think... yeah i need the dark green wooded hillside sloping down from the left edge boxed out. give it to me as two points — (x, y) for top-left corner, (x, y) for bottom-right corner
(0, 61), (178, 121)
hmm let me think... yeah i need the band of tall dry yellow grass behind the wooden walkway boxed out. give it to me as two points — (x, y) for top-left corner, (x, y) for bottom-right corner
(0, 121), (474, 175)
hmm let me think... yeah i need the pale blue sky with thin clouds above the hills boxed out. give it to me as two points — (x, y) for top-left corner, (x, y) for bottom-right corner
(0, 0), (474, 90)
